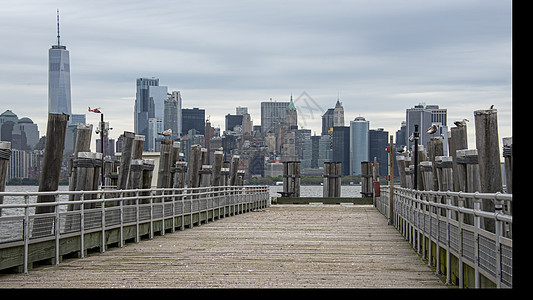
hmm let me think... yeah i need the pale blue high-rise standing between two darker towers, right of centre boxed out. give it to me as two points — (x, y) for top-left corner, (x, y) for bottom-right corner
(350, 117), (369, 175)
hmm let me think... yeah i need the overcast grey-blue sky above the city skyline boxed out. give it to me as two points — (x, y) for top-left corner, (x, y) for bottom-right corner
(0, 0), (512, 151)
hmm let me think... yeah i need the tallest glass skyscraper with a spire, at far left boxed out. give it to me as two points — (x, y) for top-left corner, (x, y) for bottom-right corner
(48, 10), (72, 116)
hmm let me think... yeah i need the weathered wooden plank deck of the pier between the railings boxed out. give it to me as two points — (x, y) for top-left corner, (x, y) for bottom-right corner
(0, 205), (446, 288)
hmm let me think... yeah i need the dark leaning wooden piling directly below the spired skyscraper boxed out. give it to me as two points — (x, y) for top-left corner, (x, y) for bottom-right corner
(34, 114), (69, 216)
